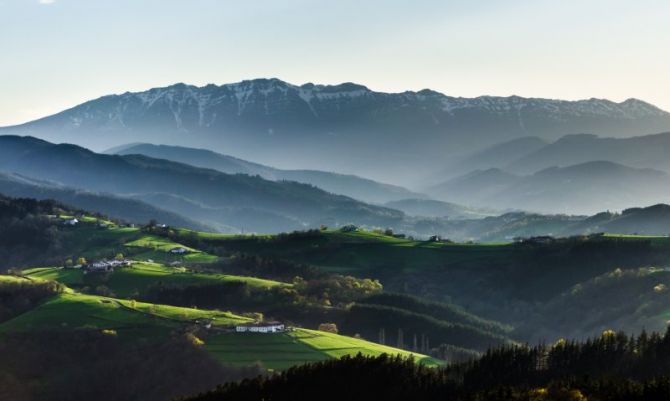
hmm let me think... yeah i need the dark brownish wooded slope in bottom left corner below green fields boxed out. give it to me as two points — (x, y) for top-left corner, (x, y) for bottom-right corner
(0, 330), (262, 401)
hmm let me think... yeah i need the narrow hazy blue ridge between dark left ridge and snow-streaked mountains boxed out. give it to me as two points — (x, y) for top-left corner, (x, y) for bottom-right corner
(107, 144), (423, 203)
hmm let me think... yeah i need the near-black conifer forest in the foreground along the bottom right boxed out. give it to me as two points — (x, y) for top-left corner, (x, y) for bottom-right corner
(184, 332), (670, 401)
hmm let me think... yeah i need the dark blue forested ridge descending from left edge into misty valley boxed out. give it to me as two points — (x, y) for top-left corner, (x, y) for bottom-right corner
(0, 136), (403, 231)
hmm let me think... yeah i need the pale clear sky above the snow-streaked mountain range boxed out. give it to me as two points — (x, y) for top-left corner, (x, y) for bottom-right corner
(0, 0), (670, 126)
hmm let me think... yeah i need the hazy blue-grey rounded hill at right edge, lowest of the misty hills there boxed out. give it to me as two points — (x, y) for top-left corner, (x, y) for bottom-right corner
(428, 161), (670, 214)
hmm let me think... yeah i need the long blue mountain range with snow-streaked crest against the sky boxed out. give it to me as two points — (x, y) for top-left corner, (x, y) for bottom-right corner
(0, 79), (670, 184)
